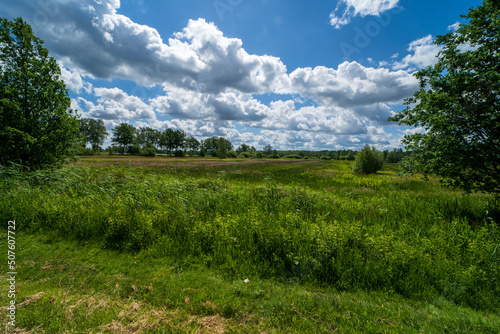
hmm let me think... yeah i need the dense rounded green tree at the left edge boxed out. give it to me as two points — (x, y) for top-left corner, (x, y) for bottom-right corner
(0, 18), (78, 167)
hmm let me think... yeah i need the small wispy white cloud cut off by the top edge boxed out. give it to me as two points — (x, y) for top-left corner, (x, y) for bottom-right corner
(330, 0), (399, 29)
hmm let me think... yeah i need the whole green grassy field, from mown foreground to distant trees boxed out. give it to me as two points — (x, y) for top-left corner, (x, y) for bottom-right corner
(0, 156), (500, 333)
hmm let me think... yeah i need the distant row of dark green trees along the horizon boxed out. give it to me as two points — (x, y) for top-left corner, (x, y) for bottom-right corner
(79, 118), (406, 163)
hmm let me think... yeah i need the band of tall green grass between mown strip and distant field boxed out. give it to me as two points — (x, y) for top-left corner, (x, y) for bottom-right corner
(0, 162), (500, 310)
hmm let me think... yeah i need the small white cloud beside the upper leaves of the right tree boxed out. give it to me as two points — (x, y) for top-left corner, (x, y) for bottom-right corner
(392, 35), (442, 72)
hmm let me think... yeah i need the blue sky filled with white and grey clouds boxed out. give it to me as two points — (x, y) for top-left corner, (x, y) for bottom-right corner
(0, 0), (481, 150)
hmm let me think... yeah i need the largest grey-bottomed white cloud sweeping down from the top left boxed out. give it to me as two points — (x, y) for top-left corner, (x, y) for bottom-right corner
(5, 0), (288, 93)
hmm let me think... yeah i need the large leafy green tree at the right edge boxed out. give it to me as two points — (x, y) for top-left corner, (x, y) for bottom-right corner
(389, 0), (500, 195)
